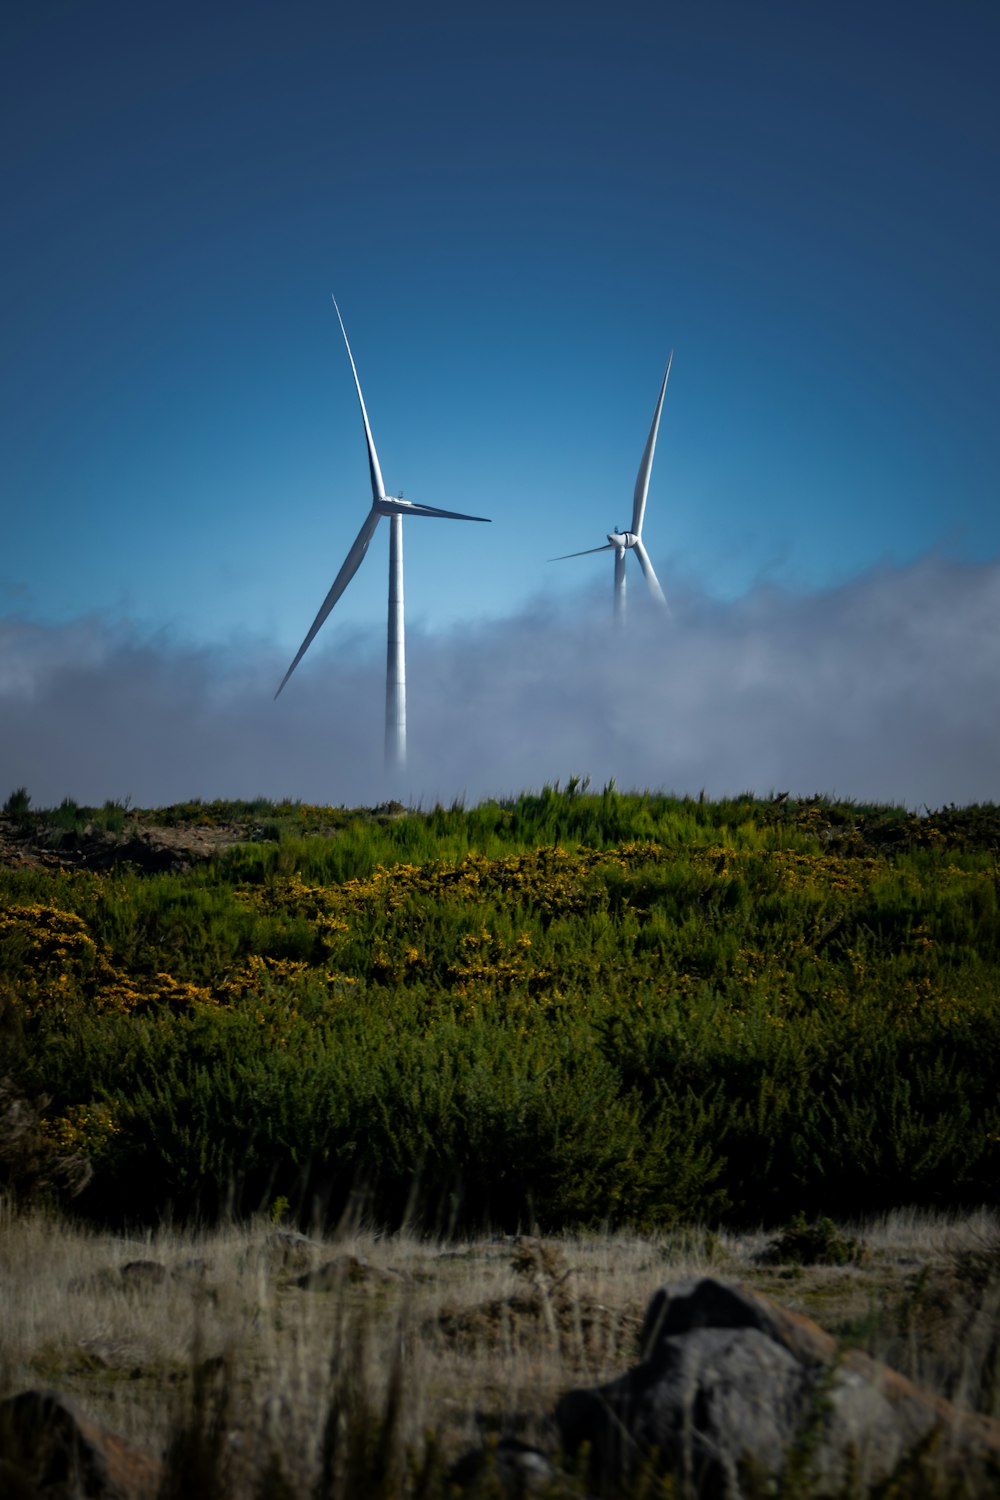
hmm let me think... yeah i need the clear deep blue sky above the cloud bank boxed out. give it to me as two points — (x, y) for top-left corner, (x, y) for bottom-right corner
(0, 0), (1000, 810)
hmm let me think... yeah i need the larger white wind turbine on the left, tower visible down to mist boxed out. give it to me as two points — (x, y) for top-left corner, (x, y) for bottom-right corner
(274, 297), (489, 770)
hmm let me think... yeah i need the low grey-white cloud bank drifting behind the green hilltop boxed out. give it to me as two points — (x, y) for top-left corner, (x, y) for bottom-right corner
(0, 558), (1000, 807)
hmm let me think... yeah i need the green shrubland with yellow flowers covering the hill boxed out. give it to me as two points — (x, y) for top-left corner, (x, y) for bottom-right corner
(0, 783), (1000, 1235)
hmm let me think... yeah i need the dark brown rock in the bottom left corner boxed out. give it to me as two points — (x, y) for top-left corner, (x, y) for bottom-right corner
(0, 1391), (162, 1500)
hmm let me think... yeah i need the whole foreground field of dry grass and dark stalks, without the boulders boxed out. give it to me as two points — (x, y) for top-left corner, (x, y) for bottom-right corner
(0, 1208), (1000, 1500)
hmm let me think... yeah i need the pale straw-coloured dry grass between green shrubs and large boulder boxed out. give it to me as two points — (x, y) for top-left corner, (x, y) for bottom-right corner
(0, 1211), (1000, 1488)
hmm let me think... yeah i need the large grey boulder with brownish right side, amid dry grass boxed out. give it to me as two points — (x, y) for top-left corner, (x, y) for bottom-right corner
(555, 1280), (1000, 1500)
